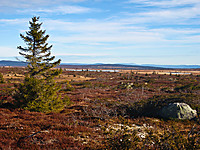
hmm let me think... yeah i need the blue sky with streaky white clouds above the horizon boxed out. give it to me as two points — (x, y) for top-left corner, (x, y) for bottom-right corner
(0, 0), (200, 65)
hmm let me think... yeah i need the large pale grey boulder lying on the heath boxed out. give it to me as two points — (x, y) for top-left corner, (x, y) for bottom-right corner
(160, 103), (197, 119)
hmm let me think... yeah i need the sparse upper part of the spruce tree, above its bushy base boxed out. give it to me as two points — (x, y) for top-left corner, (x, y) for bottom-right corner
(17, 17), (61, 79)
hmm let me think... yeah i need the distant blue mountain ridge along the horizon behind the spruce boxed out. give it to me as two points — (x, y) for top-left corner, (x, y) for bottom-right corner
(0, 60), (200, 70)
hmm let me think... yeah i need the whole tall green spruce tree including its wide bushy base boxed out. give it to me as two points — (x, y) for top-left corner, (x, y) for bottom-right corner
(14, 17), (65, 112)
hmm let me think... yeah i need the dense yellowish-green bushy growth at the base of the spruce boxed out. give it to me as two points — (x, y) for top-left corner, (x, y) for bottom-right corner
(14, 77), (69, 112)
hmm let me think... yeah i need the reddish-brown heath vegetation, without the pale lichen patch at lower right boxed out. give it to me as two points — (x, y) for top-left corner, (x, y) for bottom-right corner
(0, 68), (200, 150)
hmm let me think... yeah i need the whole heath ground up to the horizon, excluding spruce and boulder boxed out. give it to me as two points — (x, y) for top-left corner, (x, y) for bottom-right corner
(0, 67), (200, 149)
